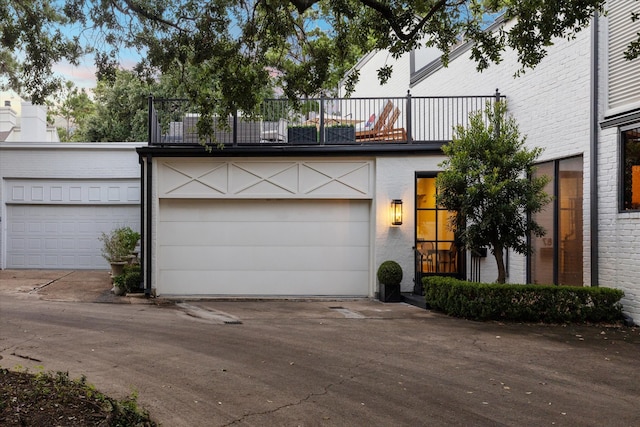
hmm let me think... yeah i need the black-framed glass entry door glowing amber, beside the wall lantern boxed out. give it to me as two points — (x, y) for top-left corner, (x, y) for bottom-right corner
(415, 174), (464, 289)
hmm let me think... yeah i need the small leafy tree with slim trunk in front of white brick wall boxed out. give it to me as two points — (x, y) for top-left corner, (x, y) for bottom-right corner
(436, 102), (551, 283)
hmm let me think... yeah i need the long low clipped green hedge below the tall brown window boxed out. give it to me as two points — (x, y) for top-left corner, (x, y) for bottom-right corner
(422, 276), (624, 323)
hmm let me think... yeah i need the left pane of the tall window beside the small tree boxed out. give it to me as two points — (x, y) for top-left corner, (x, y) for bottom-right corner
(531, 162), (555, 285)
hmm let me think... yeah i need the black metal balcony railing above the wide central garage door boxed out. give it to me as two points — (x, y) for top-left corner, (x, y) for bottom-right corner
(149, 91), (504, 147)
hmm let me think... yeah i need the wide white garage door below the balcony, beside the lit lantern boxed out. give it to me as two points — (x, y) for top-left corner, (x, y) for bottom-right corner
(156, 199), (370, 296)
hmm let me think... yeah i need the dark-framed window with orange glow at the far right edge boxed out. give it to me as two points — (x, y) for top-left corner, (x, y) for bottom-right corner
(620, 127), (640, 211)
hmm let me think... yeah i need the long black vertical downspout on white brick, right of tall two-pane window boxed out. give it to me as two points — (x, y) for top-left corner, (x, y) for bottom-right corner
(589, 12), (600, 286)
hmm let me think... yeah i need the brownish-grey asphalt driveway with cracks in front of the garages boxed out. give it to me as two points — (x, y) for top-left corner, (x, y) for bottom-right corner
(0, 271), (640, 426)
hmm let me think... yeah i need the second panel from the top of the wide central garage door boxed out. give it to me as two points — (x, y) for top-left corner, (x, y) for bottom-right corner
(158, 221), (369, 247)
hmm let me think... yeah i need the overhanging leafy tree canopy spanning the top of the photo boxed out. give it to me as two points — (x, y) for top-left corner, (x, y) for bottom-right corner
(0, 0), (638, 112)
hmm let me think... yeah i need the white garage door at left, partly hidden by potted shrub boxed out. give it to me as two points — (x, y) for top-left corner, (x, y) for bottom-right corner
(7, 205), (140, 269)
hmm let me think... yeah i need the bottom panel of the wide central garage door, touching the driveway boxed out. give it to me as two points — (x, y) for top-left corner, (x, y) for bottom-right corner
(159, 270), (368, 297)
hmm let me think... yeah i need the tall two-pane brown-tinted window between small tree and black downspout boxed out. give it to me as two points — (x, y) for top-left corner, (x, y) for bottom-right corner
(529, 156), (583, 286)
